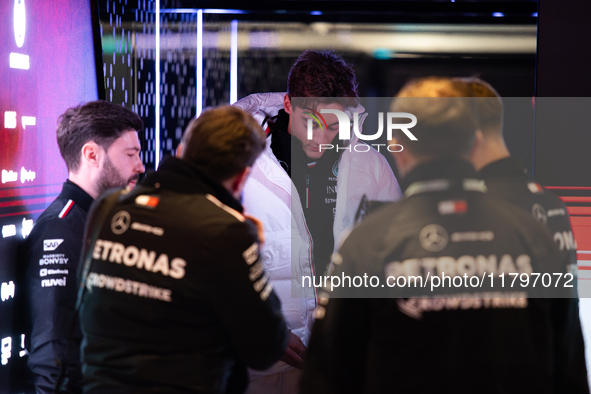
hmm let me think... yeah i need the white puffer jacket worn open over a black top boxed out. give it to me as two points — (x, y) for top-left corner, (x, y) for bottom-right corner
(234, 93), (402, 379)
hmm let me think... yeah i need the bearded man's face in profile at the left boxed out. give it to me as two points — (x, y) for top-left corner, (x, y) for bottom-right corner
(98, 130), (145, 194)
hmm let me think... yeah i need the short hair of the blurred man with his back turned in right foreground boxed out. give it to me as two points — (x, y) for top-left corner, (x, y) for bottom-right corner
(391, 77), (478, 159)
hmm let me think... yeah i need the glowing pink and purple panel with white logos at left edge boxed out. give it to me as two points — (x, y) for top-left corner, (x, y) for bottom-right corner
(0, 0), (98, 393)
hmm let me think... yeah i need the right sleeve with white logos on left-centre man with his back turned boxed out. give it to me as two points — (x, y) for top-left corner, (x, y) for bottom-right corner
(206, 222), (288, 370)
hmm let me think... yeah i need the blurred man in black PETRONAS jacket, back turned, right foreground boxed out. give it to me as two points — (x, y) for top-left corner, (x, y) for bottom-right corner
(300, 78), (589, 394)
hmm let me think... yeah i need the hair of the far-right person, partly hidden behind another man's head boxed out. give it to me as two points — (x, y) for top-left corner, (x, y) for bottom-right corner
(457, 77), (503, 136)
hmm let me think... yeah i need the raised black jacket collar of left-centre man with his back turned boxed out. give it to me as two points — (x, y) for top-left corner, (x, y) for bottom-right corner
(142, 156), (243, 213)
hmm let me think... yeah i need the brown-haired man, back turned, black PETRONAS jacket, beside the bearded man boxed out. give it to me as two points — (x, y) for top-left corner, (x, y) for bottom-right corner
(80, 107), (287, 393)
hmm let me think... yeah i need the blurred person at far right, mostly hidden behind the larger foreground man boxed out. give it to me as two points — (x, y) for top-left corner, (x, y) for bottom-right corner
(458, 78), (587, 386)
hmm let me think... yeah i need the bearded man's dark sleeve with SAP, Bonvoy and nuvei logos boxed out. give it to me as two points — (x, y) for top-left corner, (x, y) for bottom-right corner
(24, 218), (82, 390)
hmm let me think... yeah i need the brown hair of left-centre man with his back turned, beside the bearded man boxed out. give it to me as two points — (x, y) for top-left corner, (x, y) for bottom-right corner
(181, 105), (266, 182)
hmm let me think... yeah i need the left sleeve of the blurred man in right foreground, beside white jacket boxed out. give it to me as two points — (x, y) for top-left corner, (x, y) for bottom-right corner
(300, 227), (384, 394)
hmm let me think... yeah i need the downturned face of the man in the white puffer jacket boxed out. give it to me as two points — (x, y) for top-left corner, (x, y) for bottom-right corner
(289, 103), (345, 159)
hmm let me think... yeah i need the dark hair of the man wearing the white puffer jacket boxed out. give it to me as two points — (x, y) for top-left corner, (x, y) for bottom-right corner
(287, 50), (359, 107)
